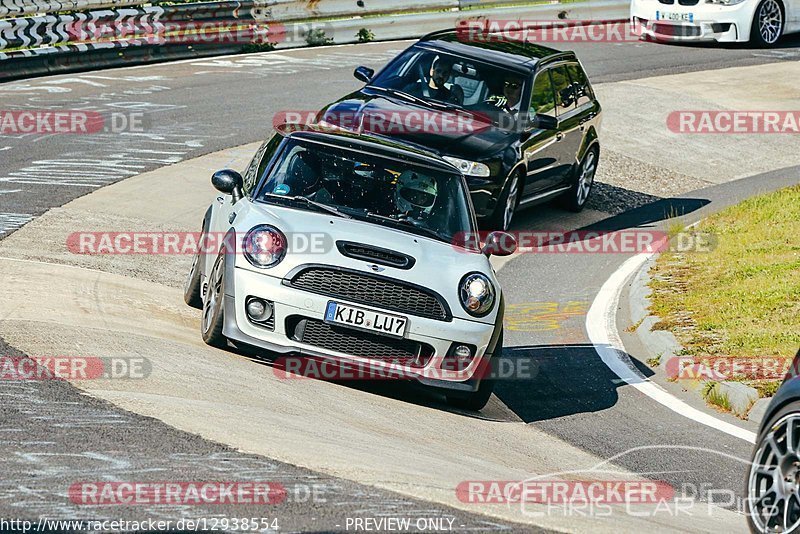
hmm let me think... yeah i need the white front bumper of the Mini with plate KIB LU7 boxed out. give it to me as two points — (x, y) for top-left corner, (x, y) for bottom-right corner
(223, 258), (502, 392)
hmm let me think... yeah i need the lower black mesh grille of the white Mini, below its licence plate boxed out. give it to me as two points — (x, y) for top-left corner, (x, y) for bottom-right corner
(288, 317), (433, 367)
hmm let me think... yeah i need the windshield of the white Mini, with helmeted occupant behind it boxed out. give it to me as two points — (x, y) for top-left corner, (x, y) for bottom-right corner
(256, 139), (473, 242)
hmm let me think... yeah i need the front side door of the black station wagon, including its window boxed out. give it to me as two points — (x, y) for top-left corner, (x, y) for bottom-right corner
(522, 69), (559, 200)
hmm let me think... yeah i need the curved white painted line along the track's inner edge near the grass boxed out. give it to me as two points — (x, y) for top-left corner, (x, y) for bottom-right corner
(586, 252), (756, 443)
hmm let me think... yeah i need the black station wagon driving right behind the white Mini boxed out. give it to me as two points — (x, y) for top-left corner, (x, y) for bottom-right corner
(317, 30), (601, 230)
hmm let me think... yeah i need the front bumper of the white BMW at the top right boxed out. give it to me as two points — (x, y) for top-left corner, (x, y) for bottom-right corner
(631, 0), (753, 43)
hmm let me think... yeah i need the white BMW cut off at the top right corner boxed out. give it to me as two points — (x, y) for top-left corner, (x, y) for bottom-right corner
(631, 0), (800, 46)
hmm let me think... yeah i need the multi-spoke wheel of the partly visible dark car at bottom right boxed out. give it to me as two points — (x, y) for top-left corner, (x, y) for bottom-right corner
(745, 401), (800, 533)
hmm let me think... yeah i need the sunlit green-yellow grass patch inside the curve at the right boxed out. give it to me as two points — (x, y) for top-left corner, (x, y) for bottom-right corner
(650, 186), (800, 392)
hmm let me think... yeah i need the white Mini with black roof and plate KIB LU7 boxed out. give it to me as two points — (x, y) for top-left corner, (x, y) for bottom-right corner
(184, 124), (516, 409)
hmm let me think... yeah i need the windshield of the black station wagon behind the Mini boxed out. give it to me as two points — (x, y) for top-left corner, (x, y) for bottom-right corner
(369, 47), (525, 119)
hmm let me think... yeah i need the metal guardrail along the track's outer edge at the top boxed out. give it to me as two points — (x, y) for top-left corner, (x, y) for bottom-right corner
(0, 0), (629, 80)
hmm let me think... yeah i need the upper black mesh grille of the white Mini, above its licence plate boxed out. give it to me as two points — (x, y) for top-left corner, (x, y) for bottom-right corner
(289, 267), (450, 321)
